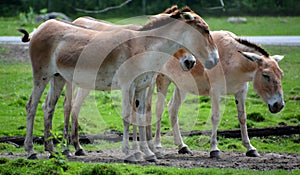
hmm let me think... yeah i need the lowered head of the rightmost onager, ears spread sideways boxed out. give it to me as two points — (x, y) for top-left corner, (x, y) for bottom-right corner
(241, 52), (284, 113)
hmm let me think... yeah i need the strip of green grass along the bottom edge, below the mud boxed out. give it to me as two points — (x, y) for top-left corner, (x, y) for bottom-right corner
(0, 158), (300, 175)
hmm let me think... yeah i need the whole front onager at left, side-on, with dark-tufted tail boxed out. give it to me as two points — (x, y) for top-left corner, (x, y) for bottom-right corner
(20, 6), (218, 161)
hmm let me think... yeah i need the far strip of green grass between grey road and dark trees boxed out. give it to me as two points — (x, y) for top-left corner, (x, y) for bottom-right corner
(0, 17), (300, 36)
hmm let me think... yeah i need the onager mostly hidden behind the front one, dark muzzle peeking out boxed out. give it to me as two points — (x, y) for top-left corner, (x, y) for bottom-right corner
(63, 6), (217, 156)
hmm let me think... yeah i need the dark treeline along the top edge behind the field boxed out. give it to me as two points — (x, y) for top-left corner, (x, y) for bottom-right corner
(0, 0), (300, 18)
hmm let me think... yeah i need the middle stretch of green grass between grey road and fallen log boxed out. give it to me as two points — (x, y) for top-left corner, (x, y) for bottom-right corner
(0, 47), (300, 136)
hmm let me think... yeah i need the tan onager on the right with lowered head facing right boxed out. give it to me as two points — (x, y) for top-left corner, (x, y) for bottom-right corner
(155, 31), (284, 157)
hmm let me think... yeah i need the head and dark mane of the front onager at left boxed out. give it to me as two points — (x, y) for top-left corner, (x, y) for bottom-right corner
(151, 6), (219, 69)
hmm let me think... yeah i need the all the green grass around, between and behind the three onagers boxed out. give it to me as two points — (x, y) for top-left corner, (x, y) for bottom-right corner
(0, 17), (300, 174)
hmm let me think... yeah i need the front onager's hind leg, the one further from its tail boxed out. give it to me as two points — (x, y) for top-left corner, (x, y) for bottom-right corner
(43, 75), (65, 157)
